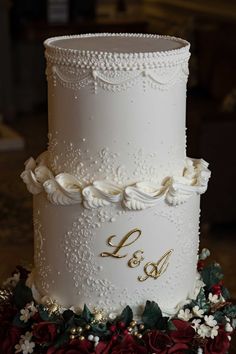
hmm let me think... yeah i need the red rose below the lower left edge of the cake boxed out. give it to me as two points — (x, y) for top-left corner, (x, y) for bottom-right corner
(33, 322), (57, 344)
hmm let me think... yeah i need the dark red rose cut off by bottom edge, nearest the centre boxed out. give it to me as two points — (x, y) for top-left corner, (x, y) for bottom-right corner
(111, 334), (148, 354)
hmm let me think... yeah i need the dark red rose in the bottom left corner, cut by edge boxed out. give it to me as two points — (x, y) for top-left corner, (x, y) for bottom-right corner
(0, 323), (21, 354)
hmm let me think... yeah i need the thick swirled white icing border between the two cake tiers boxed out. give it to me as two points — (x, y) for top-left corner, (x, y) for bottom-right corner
(21, 152), (211, 210)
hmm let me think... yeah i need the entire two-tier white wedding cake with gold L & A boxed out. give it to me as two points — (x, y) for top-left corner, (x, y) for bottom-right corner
(21, 34), (210, 313)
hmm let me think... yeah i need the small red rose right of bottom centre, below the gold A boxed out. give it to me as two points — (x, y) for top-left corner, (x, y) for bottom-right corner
(144, 331), (173, 354)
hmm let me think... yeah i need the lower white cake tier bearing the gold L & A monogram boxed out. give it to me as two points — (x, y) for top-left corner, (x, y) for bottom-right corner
(33, 193), (200, 313)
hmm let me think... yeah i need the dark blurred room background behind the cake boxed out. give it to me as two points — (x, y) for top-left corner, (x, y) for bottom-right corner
(0, 0), (236, 310)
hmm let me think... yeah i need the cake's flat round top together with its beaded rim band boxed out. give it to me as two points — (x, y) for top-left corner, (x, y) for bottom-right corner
(44, 33), (190, 70)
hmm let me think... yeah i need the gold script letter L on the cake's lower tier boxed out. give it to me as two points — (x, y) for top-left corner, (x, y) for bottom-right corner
(101, 229), (142, 258)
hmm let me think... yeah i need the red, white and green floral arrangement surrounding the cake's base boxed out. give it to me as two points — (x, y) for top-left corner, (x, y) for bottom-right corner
(0, 249), (236, 354)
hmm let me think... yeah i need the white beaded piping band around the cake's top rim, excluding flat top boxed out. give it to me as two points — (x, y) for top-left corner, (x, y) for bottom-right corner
(44, 33), (190, 70)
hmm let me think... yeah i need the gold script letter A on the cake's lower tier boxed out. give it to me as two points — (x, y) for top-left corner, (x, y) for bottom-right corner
(138, 250), (173, 281)
